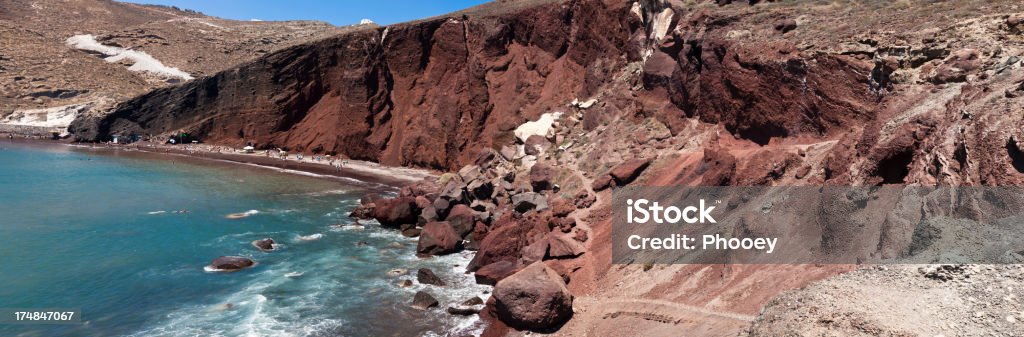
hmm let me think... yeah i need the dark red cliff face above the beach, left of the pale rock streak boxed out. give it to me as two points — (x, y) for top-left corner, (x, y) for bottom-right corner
(72, 1), (631, 169)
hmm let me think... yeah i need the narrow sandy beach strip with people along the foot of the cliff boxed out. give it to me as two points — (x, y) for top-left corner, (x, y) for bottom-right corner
(0, 135), (438, 189)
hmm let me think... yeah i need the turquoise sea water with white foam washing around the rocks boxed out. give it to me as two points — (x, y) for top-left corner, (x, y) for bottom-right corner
(0, 143), (486, 336)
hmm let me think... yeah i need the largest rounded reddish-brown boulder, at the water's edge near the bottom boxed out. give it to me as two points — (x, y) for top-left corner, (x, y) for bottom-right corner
(494, 262), (572, 331)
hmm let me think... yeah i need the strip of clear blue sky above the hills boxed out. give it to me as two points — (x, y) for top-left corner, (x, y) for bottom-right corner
(127, 0), (487, 26)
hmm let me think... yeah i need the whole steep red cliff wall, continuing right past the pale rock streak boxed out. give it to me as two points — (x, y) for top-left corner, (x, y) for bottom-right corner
(71, 0), (873, 169)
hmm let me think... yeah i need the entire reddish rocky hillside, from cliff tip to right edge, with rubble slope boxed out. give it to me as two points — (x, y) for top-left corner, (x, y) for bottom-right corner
(56, 0), (1024, 336)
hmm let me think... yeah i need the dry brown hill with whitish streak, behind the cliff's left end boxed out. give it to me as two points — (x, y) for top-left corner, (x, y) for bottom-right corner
(0, 0), (344, 122)
